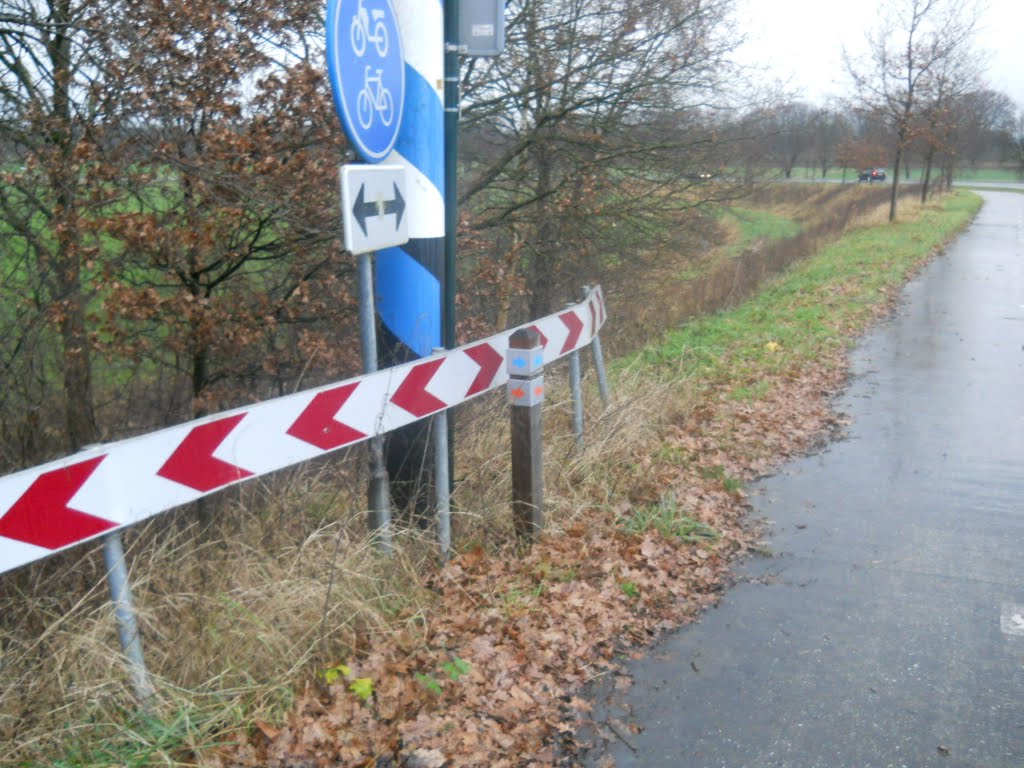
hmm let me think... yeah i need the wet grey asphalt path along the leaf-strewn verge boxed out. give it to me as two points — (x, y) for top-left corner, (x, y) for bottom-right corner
(583, 191), (1024, 768)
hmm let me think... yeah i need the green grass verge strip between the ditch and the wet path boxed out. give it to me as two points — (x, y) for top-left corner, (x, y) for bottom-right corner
(627, 190), (981, 382)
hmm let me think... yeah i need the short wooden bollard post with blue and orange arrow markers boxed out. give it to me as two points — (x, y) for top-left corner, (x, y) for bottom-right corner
(507, 329), (544, 542)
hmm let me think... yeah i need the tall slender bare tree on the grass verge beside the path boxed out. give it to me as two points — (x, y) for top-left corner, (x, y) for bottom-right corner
(846, 0), (978, 221)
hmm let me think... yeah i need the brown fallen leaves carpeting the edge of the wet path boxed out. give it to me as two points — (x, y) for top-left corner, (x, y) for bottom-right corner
(211, 358), (842, 768)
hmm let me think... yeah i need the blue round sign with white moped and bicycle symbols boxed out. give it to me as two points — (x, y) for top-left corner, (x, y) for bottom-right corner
(327, 0), (406, 163)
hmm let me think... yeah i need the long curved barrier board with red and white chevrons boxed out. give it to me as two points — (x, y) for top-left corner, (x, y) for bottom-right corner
(0, 288), (605, 572)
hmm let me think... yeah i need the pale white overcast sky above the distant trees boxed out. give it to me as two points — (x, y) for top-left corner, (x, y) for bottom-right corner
(735, 0), (1024, 110)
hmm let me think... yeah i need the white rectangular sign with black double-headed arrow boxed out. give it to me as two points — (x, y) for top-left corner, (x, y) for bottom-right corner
(341, 165), (409, 253)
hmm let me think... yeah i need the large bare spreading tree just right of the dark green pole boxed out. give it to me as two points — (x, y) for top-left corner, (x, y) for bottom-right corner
(460, 0), (735, 313)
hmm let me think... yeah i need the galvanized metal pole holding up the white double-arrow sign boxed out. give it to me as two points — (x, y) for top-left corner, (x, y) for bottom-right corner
(356, 253), (391, 553)
